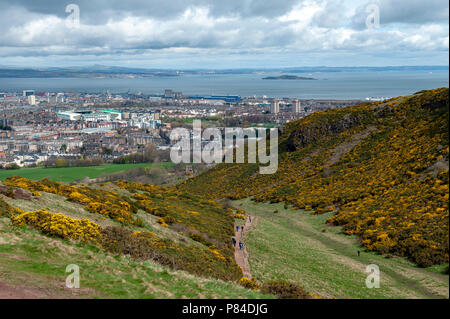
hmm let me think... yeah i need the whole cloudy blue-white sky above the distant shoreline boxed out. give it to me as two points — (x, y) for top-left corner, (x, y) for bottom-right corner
(0, 0), (449, 68)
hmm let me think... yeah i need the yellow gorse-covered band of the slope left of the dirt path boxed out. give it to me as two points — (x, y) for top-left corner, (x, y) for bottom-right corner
(2, 176), (246, 281)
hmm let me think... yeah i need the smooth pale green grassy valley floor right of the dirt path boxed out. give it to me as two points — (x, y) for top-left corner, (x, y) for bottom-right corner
(234, 199), (449, 298)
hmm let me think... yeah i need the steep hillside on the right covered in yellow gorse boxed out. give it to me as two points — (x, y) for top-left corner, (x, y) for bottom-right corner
(179, 88), (449, 267)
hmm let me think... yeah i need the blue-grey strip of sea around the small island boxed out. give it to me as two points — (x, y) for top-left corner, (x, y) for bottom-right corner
(0, 70), (449, 99)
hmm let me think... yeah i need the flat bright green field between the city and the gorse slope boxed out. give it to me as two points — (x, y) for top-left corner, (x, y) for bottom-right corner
(0, 162), (173, 182)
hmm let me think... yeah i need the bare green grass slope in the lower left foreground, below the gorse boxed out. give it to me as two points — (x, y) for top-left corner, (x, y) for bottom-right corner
(0, 215), (272, 298)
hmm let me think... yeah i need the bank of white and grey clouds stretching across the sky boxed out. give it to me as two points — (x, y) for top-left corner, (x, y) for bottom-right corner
(0, 0), (449, 64)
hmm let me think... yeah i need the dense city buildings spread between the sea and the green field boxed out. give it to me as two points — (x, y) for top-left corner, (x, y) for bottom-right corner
(0, 89), (361, 167)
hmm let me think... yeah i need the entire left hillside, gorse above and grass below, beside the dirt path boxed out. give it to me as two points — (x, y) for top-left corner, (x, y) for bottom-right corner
(0, 176), (282, 298)
